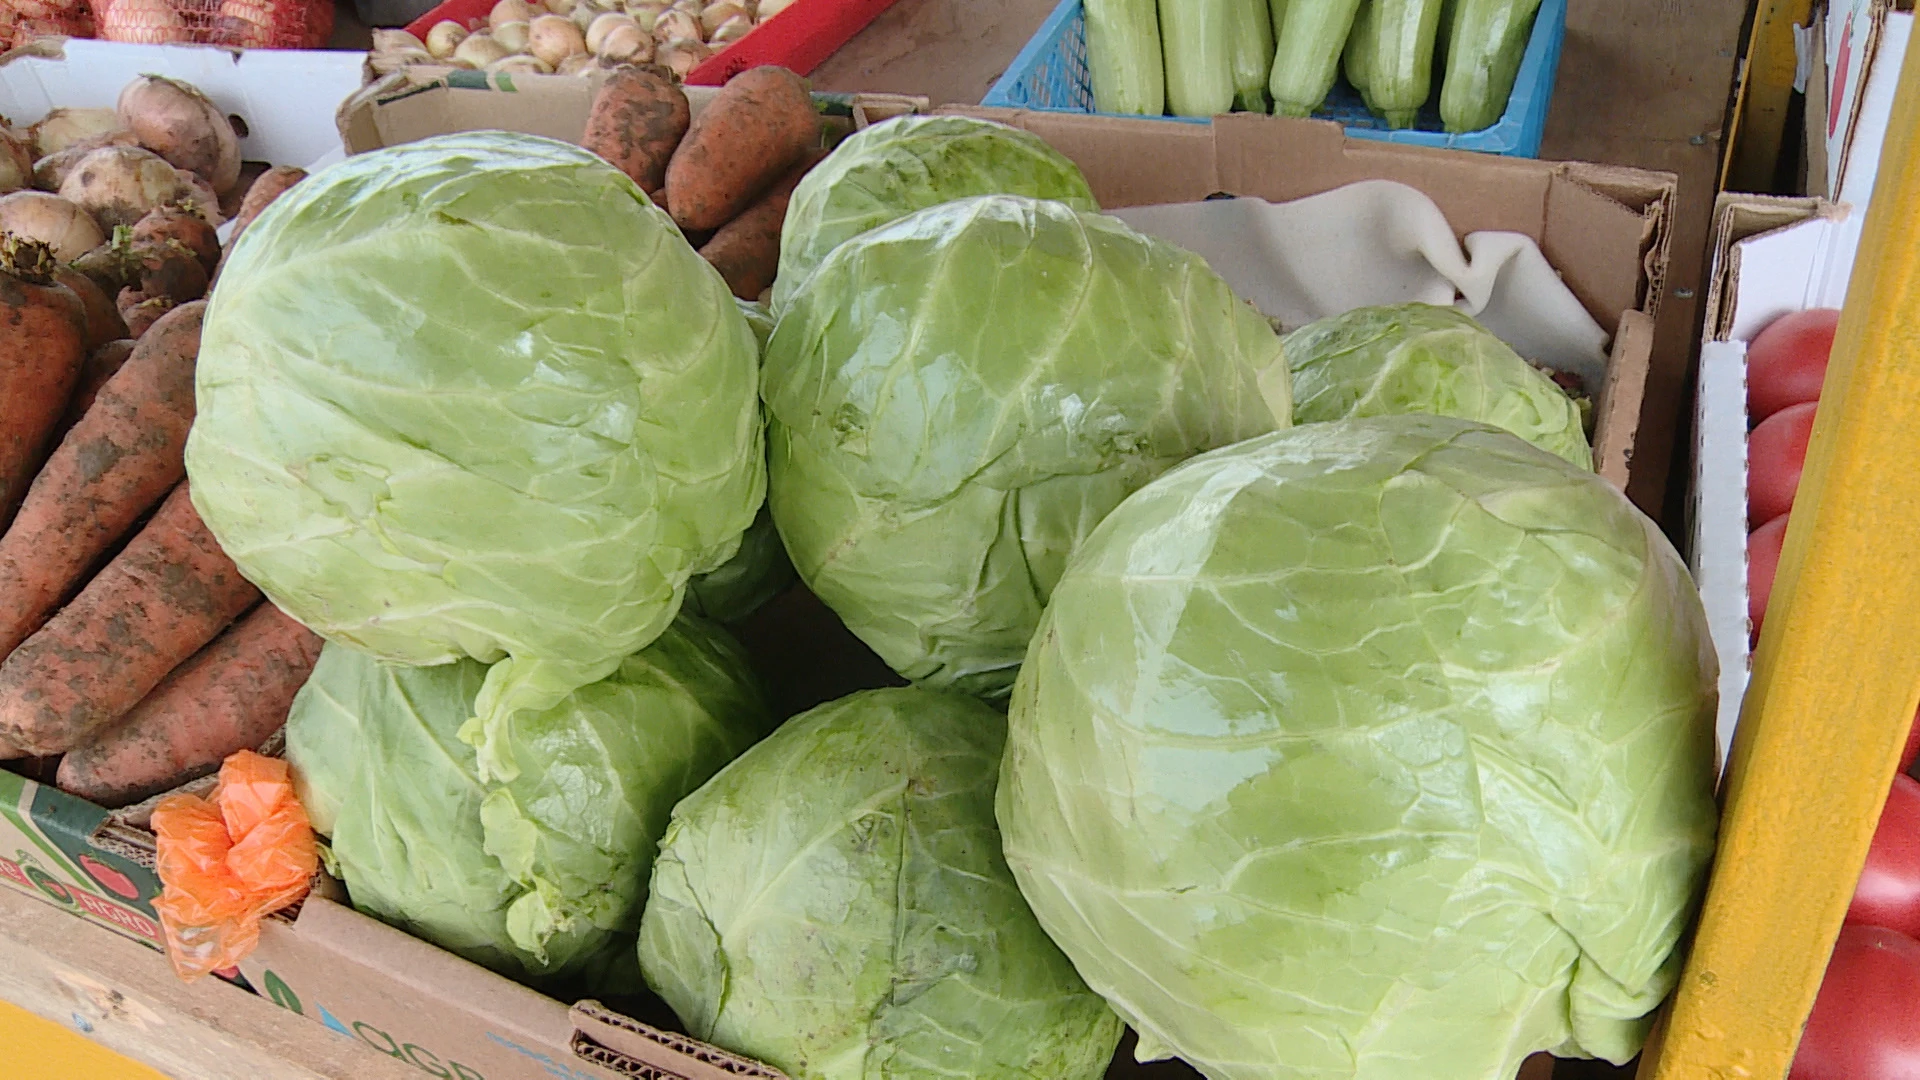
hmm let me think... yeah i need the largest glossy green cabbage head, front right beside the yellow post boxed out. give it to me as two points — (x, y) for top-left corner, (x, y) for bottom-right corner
(996, 415), (1716, 1080)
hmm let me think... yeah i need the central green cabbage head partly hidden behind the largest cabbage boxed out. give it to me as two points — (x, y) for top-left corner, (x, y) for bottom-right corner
(764, 196), (1292, 698)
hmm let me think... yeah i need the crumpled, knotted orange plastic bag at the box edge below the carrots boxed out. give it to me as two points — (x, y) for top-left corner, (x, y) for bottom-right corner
(154, 749), (319, 982)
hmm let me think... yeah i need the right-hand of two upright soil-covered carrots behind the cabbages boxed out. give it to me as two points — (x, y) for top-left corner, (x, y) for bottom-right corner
(666, 67), (820, 233)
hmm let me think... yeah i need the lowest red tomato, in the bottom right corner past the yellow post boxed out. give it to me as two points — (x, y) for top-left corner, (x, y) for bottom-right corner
(1788, 926), (1920, 1080)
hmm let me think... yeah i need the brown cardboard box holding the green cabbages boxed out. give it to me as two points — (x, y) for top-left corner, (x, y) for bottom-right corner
(255, 71), (1674, 1080)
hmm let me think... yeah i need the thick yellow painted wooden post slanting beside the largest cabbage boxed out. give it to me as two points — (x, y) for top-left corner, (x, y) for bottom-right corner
(1640, 42), (1920, 1080)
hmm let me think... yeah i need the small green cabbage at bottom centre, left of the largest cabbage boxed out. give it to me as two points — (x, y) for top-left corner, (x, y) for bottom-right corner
(639, 688), (1119, 1080)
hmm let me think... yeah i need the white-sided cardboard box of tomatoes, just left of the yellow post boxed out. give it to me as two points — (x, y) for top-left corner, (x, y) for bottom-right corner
(1688, 194), (1860, 761)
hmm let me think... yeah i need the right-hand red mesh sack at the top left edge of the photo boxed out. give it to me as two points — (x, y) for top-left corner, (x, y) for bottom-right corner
(89, 0), (334, 48)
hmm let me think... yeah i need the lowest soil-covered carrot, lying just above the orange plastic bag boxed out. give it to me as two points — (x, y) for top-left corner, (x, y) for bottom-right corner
(58, 603), (321, 807)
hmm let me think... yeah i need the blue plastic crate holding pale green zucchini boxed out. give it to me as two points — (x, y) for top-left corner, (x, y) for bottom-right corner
(981, 0), (1567, 158)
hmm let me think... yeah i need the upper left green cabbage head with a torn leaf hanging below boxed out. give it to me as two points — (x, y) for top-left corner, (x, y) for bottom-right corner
(186, 133), (764, 774)
